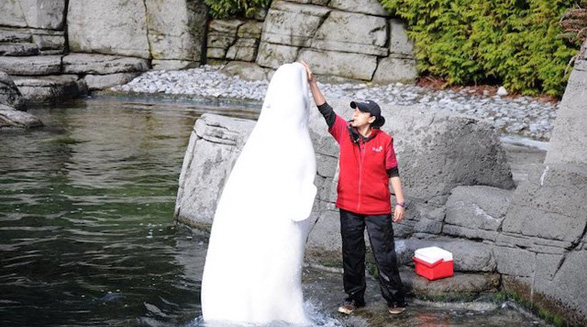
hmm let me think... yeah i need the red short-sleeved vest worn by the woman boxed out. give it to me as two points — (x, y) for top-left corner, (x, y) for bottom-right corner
(328, 115), (397, 215)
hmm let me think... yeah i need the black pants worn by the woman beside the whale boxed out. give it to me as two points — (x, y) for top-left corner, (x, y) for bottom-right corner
(340, 209), (406, 307)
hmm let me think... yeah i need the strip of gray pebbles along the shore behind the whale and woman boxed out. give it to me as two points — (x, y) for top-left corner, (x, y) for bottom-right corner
(112, 65), (558, 141)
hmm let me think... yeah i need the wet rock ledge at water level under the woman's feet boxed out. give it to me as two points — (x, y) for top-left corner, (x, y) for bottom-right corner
(303, 268), (550, 327)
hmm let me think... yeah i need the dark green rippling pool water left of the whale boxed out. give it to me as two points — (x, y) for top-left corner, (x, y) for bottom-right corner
(0, 99), (255, 327)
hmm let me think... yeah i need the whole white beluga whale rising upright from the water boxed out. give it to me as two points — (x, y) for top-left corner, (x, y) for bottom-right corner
(201, 63), (317, 325)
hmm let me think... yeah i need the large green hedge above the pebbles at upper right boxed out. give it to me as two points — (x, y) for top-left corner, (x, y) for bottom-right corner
(380, 0), (580, 96)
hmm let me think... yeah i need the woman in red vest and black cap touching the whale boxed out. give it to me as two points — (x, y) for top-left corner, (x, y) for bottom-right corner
(302, 62), (407, 314)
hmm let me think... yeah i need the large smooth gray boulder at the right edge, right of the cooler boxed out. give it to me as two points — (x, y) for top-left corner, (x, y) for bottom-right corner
(494, 164), (587, 325)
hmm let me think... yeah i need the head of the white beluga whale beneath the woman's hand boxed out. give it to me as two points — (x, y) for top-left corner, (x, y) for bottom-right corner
(258, 62), (310, 126)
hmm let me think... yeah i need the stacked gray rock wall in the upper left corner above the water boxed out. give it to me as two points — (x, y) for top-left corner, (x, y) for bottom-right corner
(0, 0), (207, 103)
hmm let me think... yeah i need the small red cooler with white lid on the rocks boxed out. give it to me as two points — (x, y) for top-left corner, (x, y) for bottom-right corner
(413, 246), (454, 280)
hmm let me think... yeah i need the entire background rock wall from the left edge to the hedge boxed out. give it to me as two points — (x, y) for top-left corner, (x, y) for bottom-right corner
(0, 0), (417, 103)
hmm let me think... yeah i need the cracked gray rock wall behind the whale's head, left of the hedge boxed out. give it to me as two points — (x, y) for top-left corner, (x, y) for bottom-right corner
(207, 0), (417, 83)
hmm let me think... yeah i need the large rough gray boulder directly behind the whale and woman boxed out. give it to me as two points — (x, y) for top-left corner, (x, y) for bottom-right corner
(176, 99), (514, 252)
